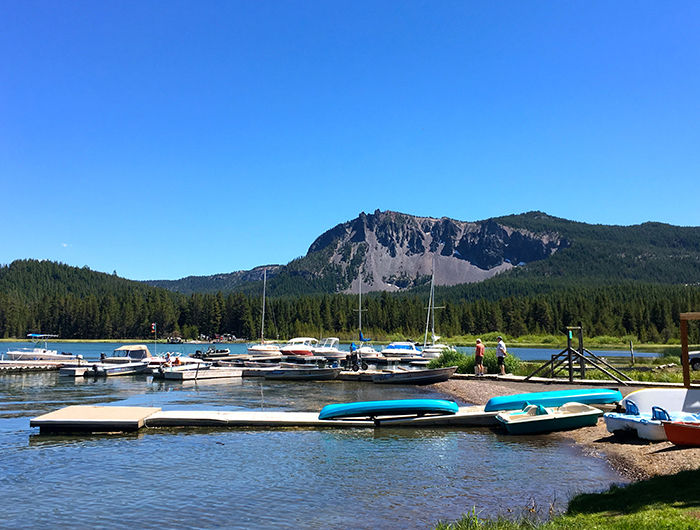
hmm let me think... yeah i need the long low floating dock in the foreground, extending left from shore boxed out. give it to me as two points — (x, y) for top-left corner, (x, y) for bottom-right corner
(29, 405), (497, 434)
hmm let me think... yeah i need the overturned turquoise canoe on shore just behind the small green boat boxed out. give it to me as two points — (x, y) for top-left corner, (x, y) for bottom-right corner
(484, 388), (622, 412)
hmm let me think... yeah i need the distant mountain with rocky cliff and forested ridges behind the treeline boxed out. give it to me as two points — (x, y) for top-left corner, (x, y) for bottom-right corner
(148, 210), (700, 296)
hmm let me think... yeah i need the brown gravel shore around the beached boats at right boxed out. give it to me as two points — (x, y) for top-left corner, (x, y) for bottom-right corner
(433, 378), (700, 480)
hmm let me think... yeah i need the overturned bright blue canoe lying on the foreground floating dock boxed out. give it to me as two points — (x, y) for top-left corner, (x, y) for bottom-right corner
(318, 399), (459, 420)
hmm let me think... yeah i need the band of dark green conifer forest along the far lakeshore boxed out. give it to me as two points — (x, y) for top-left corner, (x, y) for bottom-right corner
(0, 260), (700, 342)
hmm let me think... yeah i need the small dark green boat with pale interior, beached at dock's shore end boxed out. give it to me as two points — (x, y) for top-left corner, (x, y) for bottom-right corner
(496, 402), (603, 434)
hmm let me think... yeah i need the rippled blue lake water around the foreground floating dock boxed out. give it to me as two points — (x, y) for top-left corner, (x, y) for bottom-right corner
(0, 343), (624, 528)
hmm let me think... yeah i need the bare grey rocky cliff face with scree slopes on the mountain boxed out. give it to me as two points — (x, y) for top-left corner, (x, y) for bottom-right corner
(301, 210), (569, 292)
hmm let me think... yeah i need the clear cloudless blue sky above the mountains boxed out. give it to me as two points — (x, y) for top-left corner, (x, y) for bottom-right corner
(0, 0), (700, 279)
